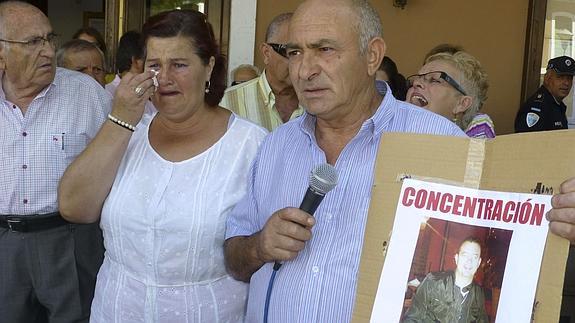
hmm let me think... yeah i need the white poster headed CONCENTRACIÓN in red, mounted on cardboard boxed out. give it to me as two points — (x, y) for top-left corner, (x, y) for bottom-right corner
(370, 179), (551, 323)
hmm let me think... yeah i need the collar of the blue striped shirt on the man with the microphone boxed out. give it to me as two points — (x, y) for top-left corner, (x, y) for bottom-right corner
(298, 84), (398, 138)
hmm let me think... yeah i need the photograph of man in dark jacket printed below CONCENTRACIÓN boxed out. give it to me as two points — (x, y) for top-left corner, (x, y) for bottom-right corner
(402, 218), (513, 322)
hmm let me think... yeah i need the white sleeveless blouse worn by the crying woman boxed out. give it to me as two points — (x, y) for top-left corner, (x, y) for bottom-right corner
(91, 115), (266, 323)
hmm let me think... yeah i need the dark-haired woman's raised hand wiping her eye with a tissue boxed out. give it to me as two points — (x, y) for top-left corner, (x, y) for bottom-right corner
(112, 71), (156, 126)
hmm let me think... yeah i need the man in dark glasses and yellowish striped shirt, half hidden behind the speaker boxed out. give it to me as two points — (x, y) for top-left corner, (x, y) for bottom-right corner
(220, 13), (303, 131)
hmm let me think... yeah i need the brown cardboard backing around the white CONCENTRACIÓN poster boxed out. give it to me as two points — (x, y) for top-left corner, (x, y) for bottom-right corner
(353, 130), (575, 322)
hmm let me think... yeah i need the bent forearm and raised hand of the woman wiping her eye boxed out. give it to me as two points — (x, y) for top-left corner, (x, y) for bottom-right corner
(58, 71), (155, 223)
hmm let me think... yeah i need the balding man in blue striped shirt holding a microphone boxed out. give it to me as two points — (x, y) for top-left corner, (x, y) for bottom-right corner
(225, 0), (575, 323)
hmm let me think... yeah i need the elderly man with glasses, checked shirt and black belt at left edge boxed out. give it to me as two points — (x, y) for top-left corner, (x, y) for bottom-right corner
(0, 1), (111, 322)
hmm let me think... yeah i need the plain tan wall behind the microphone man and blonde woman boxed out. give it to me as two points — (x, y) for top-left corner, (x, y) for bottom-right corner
(255, 0), (528, 135)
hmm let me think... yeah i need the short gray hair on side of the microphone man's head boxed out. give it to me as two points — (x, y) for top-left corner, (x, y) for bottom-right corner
(350, 0), (383, 55)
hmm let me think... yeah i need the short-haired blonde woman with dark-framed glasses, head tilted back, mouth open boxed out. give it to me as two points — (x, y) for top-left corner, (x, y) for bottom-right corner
(406, 51), (495, 138)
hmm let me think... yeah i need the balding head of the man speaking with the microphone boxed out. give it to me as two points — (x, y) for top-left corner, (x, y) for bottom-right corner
(287, 0), (385, 120)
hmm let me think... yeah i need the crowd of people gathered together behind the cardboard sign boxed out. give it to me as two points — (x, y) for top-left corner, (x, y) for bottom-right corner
(0, 0), (575, 322)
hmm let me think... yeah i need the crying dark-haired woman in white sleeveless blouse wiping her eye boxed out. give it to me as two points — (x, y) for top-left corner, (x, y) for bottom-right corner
(59, 10), (266, 323)
